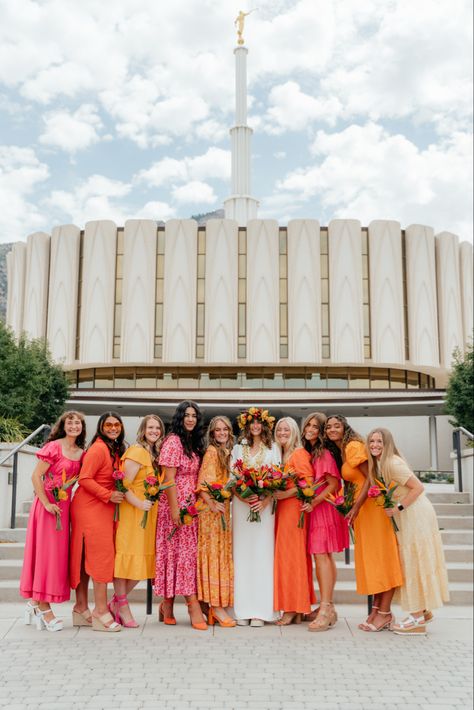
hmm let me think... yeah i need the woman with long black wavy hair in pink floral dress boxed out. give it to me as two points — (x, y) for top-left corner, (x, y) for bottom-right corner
(154, 402), (207, 631)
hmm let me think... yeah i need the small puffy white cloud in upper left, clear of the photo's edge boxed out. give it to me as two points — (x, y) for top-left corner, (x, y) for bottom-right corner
(39, 104), (102, 153)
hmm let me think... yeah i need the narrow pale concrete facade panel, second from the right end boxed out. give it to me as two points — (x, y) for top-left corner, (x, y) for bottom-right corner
(435, 232), (464, 368)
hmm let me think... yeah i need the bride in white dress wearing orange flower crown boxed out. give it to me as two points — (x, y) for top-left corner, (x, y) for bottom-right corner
(232, 407), (280, 626)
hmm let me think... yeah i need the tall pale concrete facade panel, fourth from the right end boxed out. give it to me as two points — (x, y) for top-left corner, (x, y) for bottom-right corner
(369, 220), (405, 365)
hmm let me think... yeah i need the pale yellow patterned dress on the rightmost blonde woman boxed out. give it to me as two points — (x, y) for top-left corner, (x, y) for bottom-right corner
(383, 456), (449, 611)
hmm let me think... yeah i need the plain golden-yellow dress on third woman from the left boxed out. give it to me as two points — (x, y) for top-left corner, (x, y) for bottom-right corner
(114, 444), (158, 579)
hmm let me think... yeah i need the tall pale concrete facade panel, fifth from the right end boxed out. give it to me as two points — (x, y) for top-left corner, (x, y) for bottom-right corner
(328, 219), (364, 363)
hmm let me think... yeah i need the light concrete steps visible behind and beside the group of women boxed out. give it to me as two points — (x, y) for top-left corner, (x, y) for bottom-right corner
(0, 496), (473, 605)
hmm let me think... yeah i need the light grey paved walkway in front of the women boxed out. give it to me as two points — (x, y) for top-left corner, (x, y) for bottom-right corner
(0, 604), (472, 710)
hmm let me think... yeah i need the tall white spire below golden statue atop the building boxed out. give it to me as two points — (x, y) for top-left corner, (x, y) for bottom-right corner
(224, 47), (258, 226)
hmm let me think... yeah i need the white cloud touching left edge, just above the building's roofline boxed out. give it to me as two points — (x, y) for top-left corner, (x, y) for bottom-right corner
(0, 145), (49, 242)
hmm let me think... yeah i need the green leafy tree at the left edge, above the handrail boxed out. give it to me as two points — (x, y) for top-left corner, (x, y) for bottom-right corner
(0, 322), (68, 431)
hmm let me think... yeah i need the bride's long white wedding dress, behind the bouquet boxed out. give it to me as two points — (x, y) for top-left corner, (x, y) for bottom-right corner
(232, 444), (280, 621)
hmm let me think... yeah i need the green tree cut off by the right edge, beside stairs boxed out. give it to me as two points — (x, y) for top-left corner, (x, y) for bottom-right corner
(445, 343), (474, 432)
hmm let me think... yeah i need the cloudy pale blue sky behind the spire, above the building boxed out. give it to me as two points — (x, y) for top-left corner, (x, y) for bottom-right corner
(0, 0), (472, 242)
